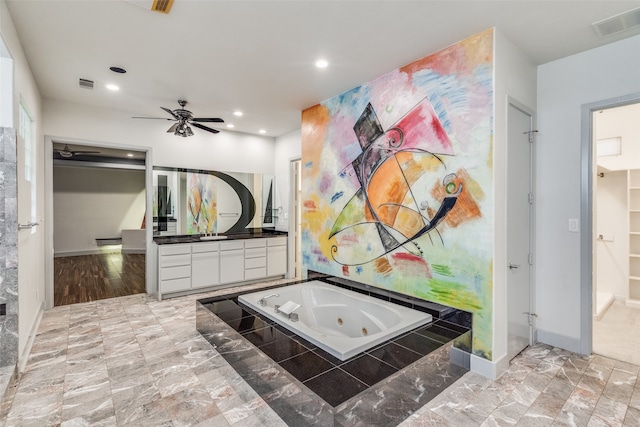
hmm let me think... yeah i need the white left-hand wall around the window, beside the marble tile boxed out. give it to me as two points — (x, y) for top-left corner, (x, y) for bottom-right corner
(0, 0), (46, 365)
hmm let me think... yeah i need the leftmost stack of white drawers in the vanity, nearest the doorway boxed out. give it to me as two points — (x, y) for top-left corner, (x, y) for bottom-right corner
(158, 244), (191, 293)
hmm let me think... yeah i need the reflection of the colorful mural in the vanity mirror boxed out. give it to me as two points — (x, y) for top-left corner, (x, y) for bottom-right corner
(187, 172), (218, 234)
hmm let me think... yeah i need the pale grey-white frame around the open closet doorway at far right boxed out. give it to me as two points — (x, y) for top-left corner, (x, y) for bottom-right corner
(579, 92), (640, 355)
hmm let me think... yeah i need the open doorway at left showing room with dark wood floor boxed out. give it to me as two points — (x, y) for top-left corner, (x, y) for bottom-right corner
(47, 140), (151, 307)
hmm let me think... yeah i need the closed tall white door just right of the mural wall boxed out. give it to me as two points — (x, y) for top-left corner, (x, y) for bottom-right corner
(507, 99), (535, 360)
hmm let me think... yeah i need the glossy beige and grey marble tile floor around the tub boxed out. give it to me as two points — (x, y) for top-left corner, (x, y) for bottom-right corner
(0, 282), (640, 427)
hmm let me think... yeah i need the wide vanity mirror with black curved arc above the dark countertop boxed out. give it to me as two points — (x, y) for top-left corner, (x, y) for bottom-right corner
(153, 167), (278, 236)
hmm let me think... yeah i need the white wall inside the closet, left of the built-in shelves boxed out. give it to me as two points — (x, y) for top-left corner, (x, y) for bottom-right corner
(593, 171), (629, 299)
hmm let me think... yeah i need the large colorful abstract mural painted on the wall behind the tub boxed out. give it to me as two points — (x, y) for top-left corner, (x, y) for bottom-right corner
(302, 30), (493, 360)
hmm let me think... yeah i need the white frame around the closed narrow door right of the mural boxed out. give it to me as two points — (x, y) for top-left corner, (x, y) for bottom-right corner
(505, 96), (537, 358)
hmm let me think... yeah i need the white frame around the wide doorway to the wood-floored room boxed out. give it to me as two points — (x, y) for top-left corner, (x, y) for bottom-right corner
(44, 135), (157, 309)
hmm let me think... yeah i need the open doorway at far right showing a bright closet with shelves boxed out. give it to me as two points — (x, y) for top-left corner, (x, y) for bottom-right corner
(590, 103), (640, 364)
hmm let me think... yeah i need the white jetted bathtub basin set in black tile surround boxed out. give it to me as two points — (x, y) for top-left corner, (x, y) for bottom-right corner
(238, 281), (432, 360)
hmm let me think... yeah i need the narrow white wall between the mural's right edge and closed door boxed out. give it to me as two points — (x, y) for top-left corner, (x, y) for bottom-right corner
(472, 30), (536, 377)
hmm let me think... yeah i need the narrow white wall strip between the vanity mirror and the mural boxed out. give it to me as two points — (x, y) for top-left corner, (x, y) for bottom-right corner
(273, 130), (302, 231)
